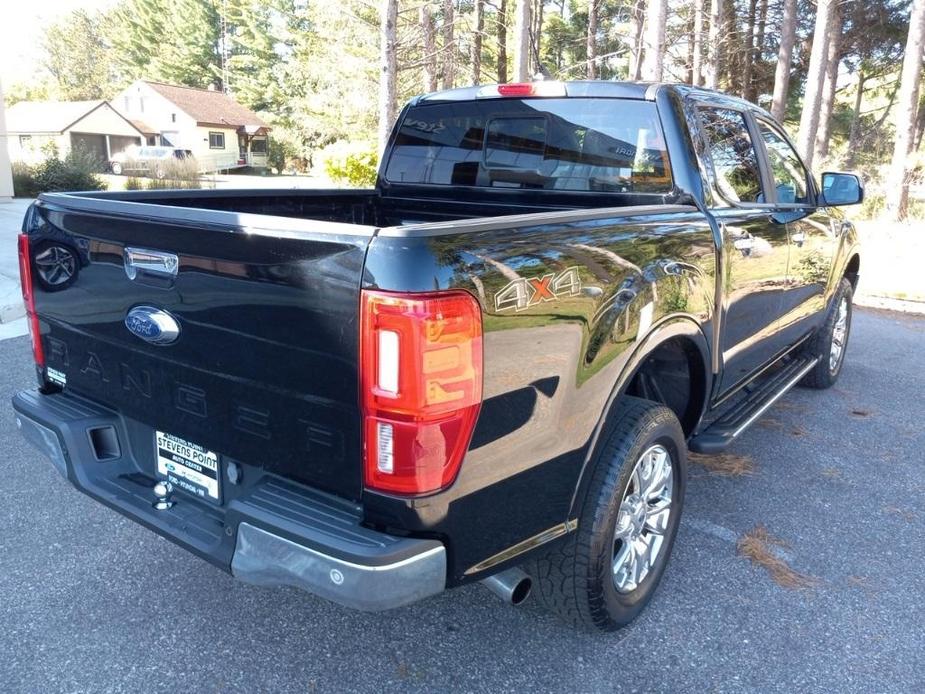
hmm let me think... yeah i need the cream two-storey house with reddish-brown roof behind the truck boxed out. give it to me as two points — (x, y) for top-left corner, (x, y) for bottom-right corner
(110, 80), (269, 171)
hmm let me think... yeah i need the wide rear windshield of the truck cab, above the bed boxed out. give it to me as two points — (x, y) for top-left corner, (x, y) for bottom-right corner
(385, 98), (672, 194)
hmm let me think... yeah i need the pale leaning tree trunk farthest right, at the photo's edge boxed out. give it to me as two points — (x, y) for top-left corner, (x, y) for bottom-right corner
(886, 0), (925, 220)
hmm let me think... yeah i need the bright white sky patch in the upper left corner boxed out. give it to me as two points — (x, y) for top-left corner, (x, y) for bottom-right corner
(0, 0), (116, 85)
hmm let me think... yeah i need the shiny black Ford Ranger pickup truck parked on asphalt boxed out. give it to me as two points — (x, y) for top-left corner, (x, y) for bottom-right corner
(13, 82), (863, 630)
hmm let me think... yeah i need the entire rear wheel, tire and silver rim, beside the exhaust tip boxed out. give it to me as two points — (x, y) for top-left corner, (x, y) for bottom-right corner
(529, 397), (687, 631)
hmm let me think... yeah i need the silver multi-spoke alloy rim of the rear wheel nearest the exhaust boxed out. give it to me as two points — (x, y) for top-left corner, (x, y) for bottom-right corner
(611, 444), (674, 594)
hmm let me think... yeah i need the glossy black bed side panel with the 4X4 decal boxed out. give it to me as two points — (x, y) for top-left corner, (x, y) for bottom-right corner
(363, 207), (715, 583)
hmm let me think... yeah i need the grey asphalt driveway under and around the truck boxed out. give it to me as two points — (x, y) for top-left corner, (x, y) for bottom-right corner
(0, 311), (925, 692)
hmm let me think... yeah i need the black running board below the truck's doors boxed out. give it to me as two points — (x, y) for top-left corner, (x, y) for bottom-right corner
(688, 357), (819, 454)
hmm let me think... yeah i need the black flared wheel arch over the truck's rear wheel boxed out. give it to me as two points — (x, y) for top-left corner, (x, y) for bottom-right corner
(568, 315), (713, 518)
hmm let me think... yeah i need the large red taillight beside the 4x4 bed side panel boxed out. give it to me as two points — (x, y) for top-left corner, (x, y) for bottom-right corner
(360, 290), (482, 494)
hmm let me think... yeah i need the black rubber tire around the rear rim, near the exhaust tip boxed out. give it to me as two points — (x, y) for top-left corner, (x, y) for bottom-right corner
(527, 396), (687, 631)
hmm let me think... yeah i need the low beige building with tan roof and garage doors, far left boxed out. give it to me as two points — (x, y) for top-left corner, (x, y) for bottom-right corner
(6, 101), (144, 170)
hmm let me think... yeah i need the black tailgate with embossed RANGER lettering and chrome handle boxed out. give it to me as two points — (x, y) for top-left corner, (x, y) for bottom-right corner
(26, 195), (375, 499)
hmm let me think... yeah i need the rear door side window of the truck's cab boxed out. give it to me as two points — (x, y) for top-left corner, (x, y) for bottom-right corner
(700, 108), (767, 203)
